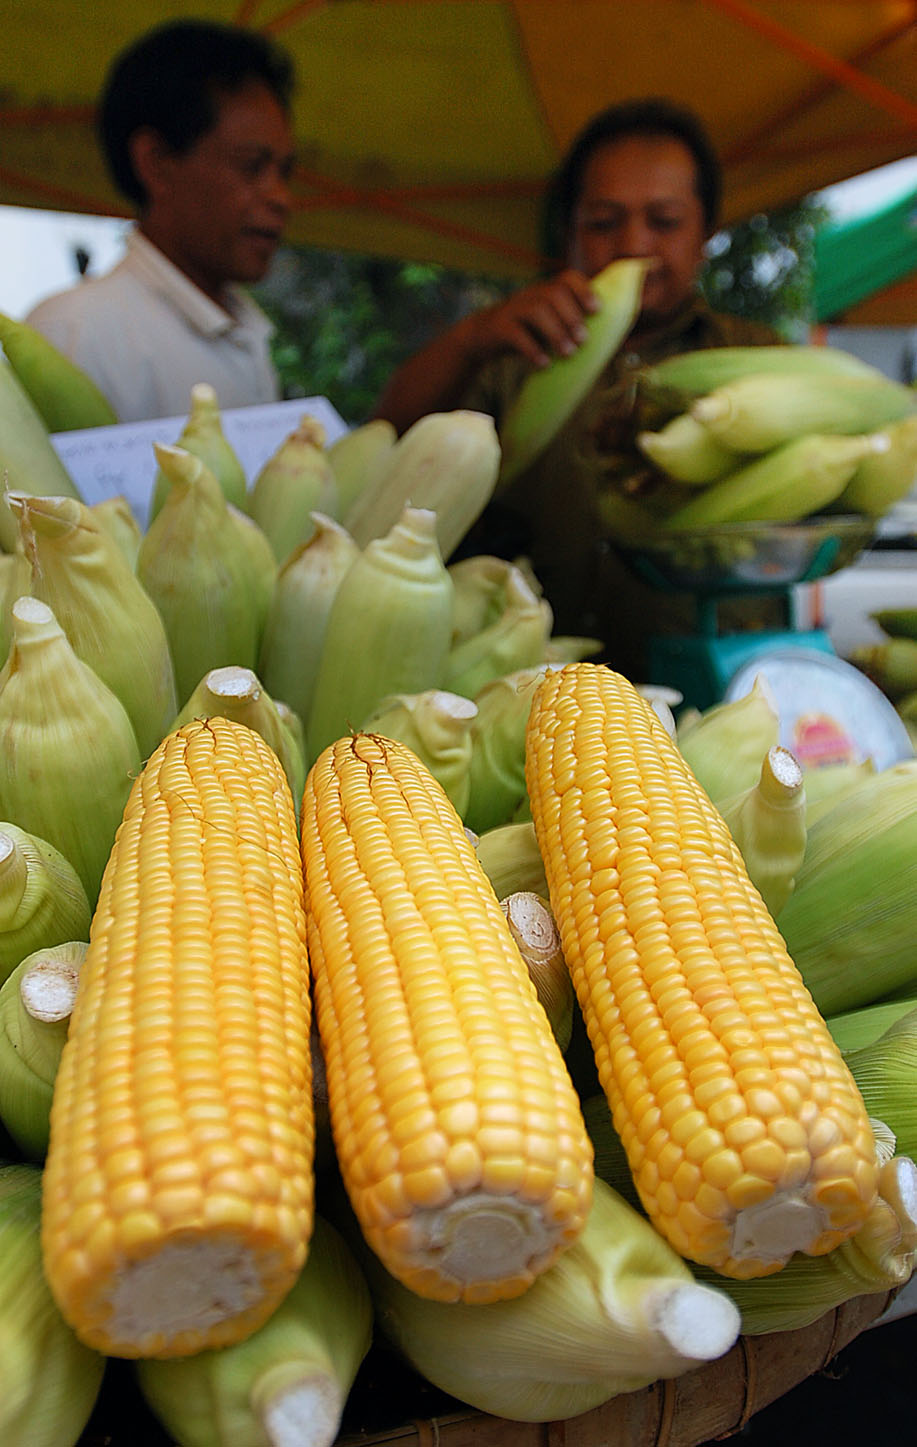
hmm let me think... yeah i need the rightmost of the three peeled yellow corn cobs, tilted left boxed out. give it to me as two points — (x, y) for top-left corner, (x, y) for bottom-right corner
(526, 663), (878, 1278)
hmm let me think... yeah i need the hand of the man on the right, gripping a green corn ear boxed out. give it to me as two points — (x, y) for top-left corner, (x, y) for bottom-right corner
(466, 271), (599, 368)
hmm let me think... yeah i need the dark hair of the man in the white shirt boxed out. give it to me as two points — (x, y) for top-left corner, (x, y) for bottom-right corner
(97, 20), (294, 207)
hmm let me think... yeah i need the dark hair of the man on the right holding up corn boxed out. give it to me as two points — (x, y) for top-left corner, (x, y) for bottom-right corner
(544, 96), (723, 259)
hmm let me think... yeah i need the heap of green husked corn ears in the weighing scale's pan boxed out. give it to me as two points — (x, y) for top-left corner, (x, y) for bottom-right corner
(624, 346), (917, 540)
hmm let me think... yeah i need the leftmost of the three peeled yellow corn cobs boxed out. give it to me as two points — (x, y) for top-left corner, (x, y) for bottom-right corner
(42, 718), (312, 1357)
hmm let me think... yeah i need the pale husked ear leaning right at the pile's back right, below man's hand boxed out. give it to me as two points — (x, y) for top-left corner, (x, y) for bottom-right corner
(344, 411), (500, 559)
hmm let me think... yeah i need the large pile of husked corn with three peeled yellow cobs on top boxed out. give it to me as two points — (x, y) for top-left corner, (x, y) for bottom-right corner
(0, 298), (917, 1447)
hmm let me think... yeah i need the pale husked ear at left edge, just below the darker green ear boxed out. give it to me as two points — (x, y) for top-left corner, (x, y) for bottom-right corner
(0, 359), (80, 553)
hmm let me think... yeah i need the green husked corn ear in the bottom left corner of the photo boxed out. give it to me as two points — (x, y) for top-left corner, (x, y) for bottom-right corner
(0, 1165), (106, 1447)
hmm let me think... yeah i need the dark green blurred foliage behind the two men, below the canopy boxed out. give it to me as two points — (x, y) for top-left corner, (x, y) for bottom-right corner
(255, 201), (827, 425)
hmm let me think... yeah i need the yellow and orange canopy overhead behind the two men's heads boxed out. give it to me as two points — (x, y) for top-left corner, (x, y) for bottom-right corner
(0, 0), (917, 275)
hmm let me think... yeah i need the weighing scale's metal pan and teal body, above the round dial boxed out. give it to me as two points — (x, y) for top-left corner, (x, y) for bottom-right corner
(610, 517), (875, 709)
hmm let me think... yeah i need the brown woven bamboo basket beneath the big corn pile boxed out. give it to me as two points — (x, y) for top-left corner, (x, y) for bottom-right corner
(77, 1292), (894, 1447)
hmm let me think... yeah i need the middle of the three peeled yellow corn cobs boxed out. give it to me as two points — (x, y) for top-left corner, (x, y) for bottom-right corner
(301, 734), (593, 1302)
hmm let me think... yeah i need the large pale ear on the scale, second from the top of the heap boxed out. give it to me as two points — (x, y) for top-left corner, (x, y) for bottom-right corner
(691, 373), (916, 453)
